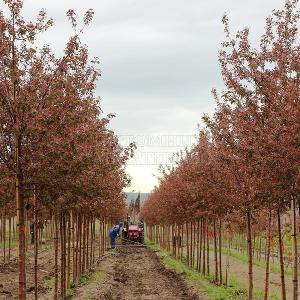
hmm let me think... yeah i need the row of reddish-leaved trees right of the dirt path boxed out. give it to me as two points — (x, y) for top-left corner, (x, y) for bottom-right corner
(142, 0), (300, 299)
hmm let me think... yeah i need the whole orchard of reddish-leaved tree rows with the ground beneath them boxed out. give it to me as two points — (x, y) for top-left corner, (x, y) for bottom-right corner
(0, 0), (300, 300)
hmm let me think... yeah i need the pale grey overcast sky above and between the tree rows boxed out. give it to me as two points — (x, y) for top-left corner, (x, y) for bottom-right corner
(4, 0), (284, 191)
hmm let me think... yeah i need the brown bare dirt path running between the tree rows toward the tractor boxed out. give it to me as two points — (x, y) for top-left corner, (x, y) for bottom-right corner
(74, 248), (199, 300)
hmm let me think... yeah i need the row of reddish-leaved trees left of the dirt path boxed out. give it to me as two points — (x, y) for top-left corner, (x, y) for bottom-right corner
(0, 0), (134, 299)
